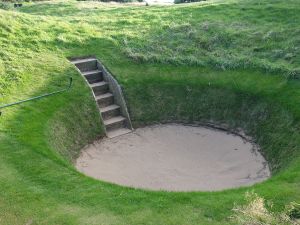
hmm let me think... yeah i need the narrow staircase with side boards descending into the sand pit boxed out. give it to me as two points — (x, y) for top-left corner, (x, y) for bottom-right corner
(71, 57), (132, 138)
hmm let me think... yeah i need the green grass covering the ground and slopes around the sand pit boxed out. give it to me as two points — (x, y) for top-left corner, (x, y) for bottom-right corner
(0, 0), (300, 225)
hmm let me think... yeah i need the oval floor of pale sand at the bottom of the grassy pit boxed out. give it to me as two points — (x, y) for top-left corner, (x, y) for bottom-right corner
(76, 124), (270, 191)
